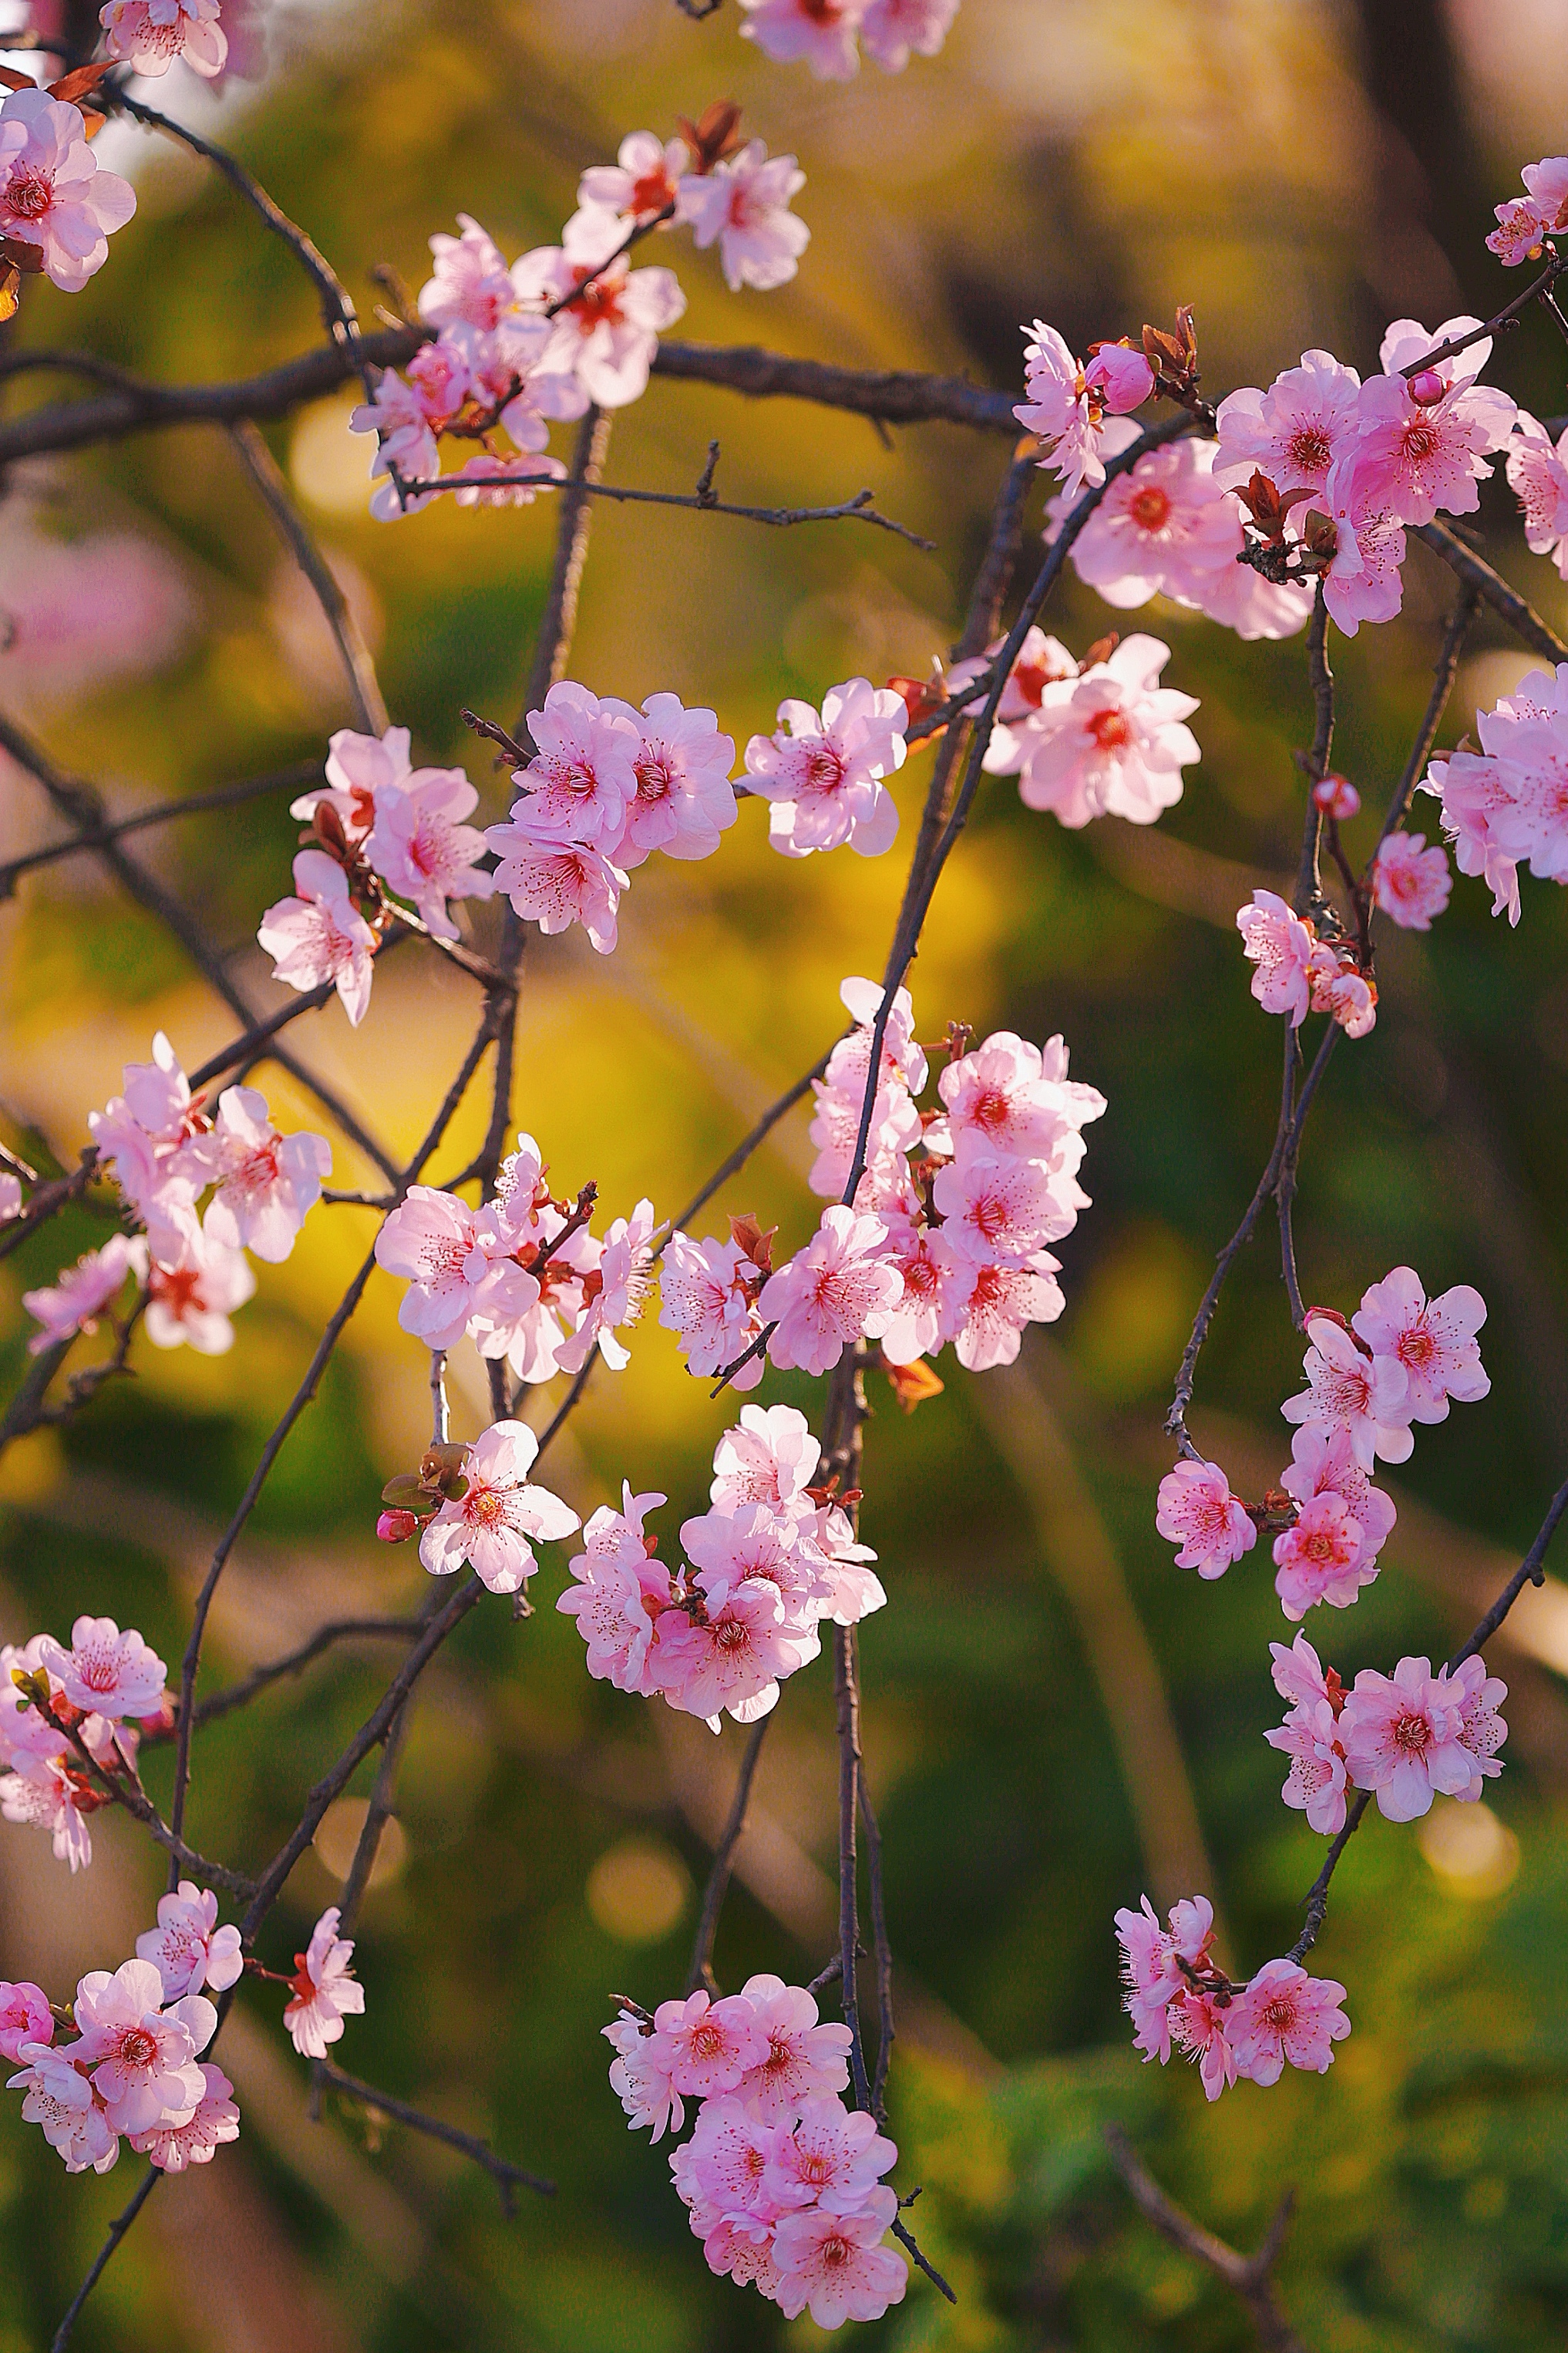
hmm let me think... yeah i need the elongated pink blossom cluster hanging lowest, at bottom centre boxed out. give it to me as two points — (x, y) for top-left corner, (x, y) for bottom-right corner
(605, 1977), (909, 2329)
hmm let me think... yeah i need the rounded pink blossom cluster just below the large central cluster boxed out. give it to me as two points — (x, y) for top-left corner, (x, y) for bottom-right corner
(556, 1405), (887, 1732)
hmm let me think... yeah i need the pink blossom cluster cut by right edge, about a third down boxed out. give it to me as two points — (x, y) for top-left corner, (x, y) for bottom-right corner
(1422, 661), (1568, 922)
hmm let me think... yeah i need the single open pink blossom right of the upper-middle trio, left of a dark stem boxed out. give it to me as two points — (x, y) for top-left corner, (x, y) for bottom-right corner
(746, 678), (909, 859)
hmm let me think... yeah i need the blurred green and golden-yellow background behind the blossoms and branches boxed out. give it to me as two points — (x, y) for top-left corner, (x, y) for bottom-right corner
(0, 0), (1568, 2353)
